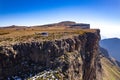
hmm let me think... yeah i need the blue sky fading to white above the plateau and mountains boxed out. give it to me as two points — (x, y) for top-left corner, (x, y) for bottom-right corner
(0, 0), (120, 38)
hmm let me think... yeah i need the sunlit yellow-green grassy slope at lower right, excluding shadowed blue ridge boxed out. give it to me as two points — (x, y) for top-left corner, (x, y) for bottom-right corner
(101, 57), (120, 80)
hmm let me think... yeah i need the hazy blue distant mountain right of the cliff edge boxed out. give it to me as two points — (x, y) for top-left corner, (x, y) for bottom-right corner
(100, 38), (120, 61)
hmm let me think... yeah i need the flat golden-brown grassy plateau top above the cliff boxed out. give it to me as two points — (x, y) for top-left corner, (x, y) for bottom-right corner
(0, 27), (96, 45)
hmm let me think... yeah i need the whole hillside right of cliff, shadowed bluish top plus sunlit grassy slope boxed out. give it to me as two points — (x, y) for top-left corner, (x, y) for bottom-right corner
(100, 48), (120, 80)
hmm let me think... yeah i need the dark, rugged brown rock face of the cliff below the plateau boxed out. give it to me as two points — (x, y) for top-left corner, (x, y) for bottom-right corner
(0, 30), (102, 80)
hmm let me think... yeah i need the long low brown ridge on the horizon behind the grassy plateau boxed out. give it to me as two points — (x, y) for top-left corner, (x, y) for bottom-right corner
(0, 21), (90, 29)
